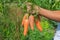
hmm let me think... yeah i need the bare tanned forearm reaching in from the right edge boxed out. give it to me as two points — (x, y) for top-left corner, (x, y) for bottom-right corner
(38, 8), (60, 21)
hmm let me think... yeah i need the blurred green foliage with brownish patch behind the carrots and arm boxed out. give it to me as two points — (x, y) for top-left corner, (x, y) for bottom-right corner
(0, 0), (60, 40)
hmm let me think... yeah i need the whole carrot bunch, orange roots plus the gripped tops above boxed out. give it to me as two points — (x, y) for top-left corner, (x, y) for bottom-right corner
(22, 2), (42, 36)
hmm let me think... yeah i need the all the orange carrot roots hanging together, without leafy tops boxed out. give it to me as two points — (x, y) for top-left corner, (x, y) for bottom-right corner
(22, 14), (42, 36)
